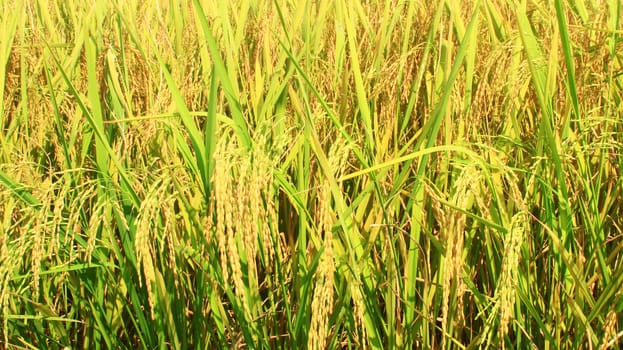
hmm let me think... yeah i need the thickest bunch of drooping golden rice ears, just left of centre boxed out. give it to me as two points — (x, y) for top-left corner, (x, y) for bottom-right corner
(213, 130), (283, 324)
